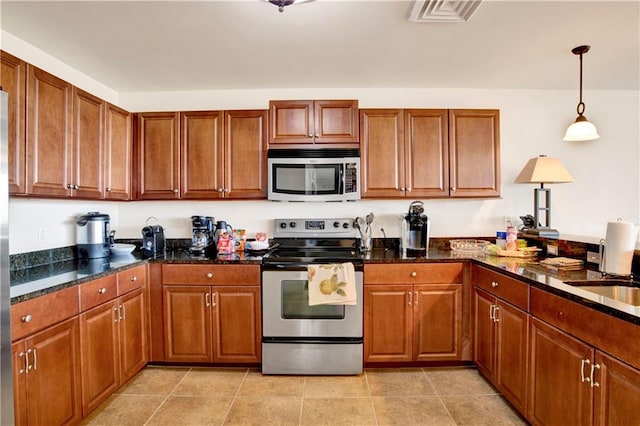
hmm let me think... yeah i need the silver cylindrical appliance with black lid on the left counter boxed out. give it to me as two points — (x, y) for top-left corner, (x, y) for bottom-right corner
(76, 212), (111, 259)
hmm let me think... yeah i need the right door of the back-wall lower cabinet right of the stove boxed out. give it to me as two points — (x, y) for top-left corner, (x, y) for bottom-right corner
(413, 284), (462, 361)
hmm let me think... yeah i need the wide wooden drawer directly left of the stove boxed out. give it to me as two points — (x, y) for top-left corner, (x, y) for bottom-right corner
(162, 265), (260, 285)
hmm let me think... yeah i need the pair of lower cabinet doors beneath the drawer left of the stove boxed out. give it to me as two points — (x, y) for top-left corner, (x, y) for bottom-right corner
(163, 285), (262, 363)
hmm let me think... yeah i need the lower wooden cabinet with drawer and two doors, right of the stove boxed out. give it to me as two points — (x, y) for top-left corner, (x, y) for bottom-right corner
(364, 263), (463, 363)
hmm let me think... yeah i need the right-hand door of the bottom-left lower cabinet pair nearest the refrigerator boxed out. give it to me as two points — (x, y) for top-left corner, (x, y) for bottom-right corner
(26, 318), (82, 425)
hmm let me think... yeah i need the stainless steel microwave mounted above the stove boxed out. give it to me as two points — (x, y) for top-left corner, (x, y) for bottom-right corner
(267, 148), (360, 201)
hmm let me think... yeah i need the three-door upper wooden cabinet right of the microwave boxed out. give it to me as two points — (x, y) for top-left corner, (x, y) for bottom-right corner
(360, 109), (500, 198)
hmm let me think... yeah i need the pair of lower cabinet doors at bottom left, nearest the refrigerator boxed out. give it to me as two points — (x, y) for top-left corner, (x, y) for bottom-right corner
(12, 317), (82, 425)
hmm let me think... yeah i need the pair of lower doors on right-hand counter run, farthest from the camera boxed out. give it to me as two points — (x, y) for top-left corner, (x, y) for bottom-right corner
(474, 288), (529, 413)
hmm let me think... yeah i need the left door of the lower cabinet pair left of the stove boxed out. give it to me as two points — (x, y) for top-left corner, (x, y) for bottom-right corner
(163, 285), (213, 362)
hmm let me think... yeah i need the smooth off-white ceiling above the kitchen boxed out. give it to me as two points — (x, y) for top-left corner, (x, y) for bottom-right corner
(0, 0), (640, 93)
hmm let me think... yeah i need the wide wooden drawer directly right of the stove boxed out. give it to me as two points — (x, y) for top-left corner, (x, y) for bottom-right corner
(364, 263), (464, 284)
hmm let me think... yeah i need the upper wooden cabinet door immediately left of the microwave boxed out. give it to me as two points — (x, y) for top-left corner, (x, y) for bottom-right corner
(224, 110), (269, 199)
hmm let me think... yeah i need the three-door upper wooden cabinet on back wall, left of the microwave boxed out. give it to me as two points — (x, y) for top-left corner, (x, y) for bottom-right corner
(136, 110), (267, 199)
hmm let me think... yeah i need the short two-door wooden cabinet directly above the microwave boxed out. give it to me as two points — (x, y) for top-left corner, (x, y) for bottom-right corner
(269, 100), (359, 147)
